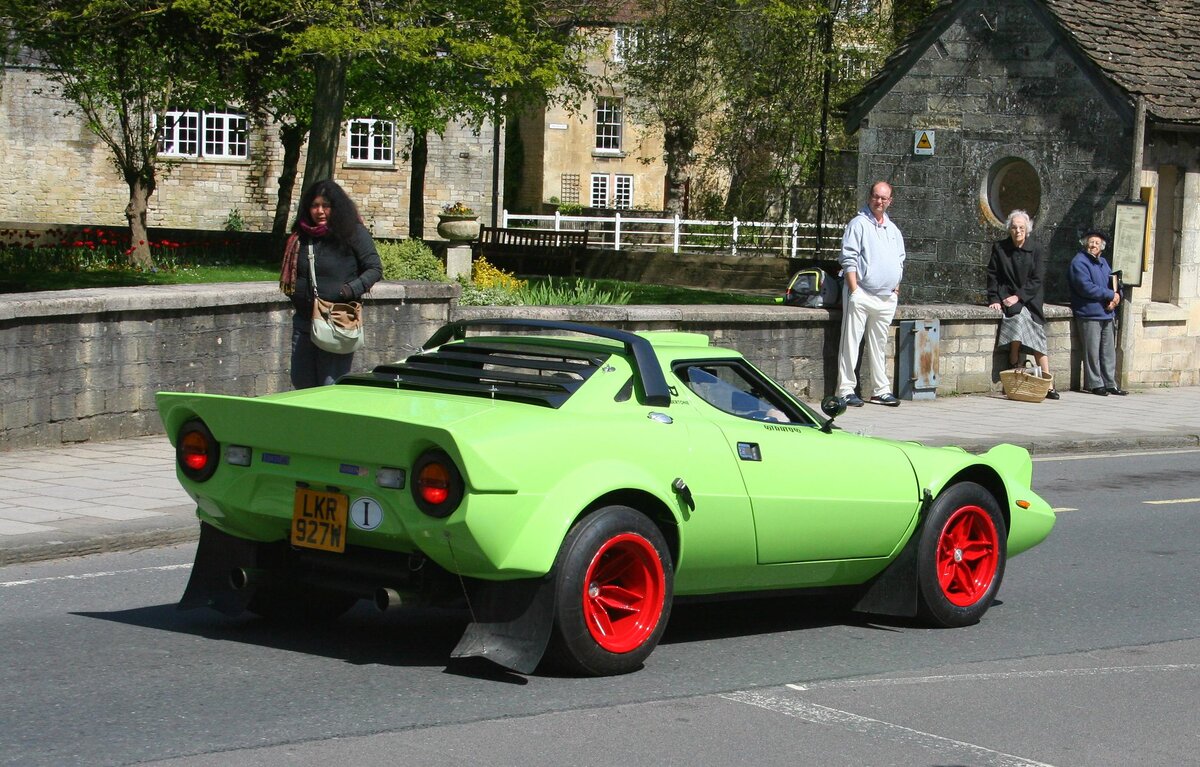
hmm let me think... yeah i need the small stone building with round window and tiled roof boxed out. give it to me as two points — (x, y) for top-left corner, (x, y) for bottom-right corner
(844, 0), (1200, 387)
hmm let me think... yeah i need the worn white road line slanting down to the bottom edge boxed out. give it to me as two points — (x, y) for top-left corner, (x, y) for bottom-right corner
(721, 690), (1051, 767)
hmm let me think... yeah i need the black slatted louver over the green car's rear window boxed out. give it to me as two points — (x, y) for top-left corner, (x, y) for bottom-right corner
(337, 337), (608, 408)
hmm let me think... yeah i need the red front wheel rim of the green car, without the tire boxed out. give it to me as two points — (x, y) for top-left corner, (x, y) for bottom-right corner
(937, 505), (1000, 607)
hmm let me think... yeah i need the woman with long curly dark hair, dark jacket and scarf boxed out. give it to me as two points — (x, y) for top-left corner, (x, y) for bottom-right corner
(280, 180), (383, 389)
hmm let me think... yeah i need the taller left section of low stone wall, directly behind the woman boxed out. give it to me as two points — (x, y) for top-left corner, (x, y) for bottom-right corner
(0, 282), (458, 450)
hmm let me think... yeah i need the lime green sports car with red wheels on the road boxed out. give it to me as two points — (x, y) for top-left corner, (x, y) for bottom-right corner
(158, 319), (1055, 675)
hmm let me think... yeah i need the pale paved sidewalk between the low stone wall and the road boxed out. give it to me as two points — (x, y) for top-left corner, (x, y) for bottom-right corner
(0, 388), (1200, 565)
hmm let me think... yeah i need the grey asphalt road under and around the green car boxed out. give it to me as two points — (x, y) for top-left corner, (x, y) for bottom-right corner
(0, 450), (1200, 767)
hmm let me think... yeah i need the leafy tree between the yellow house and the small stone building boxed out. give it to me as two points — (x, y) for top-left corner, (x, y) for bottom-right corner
(619, 0), (890, 220)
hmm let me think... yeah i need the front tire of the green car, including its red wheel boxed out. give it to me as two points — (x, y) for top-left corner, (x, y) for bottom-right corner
(917, 483), (1008, 628)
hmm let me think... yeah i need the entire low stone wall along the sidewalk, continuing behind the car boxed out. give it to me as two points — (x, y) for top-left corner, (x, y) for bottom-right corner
(0, 282), (1070, 450)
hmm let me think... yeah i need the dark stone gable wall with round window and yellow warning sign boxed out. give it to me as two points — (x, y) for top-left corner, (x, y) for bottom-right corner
(858, 0), (1133, 302)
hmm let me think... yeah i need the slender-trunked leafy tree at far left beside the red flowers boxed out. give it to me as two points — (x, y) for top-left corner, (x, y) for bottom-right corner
(0, 0), (215, 269)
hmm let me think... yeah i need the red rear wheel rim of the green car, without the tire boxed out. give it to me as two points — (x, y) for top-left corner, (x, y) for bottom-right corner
(583, 533), (666, 653)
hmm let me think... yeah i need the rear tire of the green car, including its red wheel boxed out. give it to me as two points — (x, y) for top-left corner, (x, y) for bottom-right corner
(547, 505), (674, 676)
